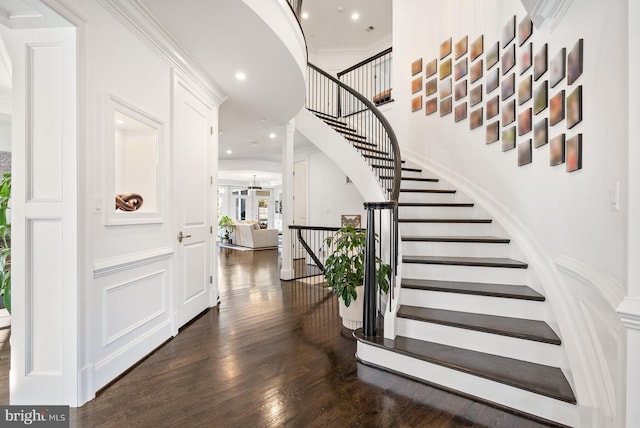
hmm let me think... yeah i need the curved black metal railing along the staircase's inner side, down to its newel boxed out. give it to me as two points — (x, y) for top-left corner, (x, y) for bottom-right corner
(301, 64), (402, 337)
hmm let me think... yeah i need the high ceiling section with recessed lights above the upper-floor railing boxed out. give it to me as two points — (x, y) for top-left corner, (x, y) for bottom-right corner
(302, 0), (392, 50)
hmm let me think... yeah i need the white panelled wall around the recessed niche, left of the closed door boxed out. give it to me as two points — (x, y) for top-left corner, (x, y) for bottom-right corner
(68, 0), (181, 402)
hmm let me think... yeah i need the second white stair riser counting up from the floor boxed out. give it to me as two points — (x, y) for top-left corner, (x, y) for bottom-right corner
(396, 318), (568, 368)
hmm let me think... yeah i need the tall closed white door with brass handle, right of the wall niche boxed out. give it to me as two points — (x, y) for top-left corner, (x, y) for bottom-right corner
(173, 77), (215, 330)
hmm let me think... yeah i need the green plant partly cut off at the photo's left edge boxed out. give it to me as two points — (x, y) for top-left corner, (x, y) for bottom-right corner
(0, 172), (11, 313)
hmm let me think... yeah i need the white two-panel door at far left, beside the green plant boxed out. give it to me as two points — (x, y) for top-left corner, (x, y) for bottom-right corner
(6, 28), (79, 405)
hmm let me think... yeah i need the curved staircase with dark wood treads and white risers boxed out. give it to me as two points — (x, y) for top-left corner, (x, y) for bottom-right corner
(307, 61), (579, 426)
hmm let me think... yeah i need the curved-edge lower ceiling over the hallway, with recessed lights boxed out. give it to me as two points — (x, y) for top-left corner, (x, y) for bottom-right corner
(140, 0), (304, 165)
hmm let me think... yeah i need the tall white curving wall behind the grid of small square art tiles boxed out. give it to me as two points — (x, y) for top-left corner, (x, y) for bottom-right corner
(391, 0), (630, 420)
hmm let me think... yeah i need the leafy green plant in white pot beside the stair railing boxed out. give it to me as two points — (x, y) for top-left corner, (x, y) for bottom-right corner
(324, 226), (391, 330)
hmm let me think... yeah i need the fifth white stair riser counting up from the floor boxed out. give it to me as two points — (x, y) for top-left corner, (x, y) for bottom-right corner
(402, 241), (511, 257)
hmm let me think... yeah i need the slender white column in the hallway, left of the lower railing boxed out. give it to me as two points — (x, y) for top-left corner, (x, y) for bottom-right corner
(280, 119), (296, 280)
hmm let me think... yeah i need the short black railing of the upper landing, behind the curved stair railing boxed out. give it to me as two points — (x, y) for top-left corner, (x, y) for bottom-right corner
(337, 48), (393, 106)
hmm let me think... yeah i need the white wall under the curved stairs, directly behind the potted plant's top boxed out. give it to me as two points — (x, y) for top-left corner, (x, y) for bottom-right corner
(308, 152), (366, 227)
